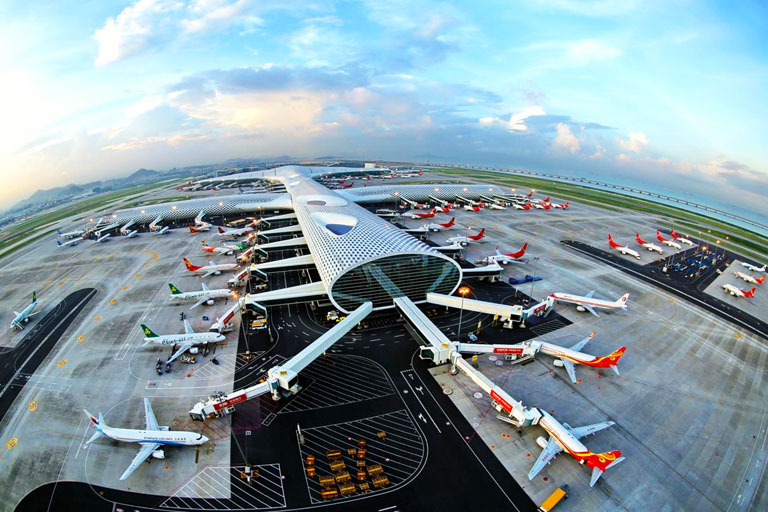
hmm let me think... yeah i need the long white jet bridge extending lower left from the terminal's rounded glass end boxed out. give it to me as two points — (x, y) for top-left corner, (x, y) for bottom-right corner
(189, 302), (373, 421)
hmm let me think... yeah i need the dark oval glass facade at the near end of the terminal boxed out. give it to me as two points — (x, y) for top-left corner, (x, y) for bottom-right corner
(331, 254), (461, 311)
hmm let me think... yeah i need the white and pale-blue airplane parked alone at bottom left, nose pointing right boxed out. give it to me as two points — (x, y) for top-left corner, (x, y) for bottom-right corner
(83, 398), (208, 480)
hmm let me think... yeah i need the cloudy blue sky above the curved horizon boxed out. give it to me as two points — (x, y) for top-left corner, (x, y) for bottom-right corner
(0, 0), (768, 213)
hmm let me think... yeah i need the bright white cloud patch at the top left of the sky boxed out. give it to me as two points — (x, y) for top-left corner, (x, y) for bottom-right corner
(93, 0), (181, 66)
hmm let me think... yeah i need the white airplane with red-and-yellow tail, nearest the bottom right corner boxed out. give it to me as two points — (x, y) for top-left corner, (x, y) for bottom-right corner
(520, 409), (624, 487)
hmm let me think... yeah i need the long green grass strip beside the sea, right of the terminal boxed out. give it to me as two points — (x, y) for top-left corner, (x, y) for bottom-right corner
(431, 168), (768, 259)
